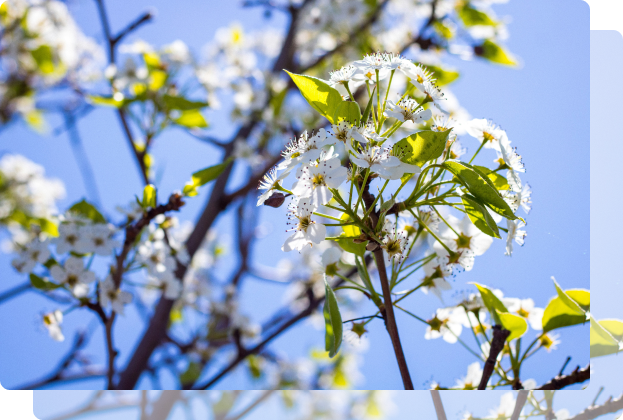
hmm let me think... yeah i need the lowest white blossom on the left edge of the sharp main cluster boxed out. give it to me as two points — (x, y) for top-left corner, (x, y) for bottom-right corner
(281, 198), (327, 252)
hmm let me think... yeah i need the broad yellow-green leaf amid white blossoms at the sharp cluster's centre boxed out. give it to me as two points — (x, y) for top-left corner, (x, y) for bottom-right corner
(394, 130), (450, 166)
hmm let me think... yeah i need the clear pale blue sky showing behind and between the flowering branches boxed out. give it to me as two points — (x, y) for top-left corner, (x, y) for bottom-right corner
(0, 0), (623, 419)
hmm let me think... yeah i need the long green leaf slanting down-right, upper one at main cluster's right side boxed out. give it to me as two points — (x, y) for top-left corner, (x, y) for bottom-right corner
(443, 160), (517, 220)
